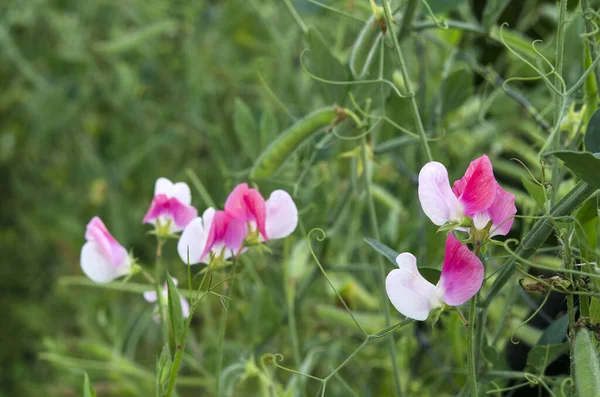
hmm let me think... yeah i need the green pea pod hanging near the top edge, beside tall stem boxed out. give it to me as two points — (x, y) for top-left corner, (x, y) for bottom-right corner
(350, 15), (381, 79)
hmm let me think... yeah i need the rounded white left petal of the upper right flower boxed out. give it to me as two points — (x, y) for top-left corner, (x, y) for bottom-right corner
(419, 161), (462, 226)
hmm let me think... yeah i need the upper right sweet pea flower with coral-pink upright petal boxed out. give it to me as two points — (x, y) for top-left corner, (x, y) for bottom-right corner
(419, 155), (517, 237)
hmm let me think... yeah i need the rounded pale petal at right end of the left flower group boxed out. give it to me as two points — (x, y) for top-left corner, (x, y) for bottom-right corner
(265, 190), (298, 238)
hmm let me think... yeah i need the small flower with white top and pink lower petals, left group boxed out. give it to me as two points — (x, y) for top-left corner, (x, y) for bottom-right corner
(143, 178), (198, 233)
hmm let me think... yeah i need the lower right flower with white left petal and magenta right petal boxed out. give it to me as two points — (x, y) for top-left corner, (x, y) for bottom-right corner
(385, 233), (484, 321)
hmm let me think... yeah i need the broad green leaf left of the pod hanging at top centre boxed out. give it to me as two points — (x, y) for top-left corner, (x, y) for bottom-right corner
(305, 28), (350, 106)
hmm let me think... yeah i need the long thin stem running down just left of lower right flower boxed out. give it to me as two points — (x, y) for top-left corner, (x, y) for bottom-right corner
(361, 137), (402, 396)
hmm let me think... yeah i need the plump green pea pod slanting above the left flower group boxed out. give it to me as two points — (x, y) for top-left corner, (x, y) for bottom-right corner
(250, 107), (339, 179)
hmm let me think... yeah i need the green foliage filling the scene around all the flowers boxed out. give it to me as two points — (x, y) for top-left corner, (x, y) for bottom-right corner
(0, 0), (600, 397)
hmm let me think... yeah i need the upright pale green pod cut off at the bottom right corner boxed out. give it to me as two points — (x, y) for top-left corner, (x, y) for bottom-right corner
(574, 328), (600, 397)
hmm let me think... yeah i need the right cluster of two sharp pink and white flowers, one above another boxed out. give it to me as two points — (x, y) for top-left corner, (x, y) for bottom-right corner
(386, 155), (517, 321)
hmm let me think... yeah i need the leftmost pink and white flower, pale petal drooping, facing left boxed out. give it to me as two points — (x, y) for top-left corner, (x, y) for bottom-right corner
(80, 216), (132, 283)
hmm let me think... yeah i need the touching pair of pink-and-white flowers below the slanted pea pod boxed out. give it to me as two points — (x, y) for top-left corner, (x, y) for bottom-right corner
(177, 183), (298, 264)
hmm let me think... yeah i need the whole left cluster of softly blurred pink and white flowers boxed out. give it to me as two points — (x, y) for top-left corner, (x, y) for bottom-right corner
(80, 178), (298, 316)
